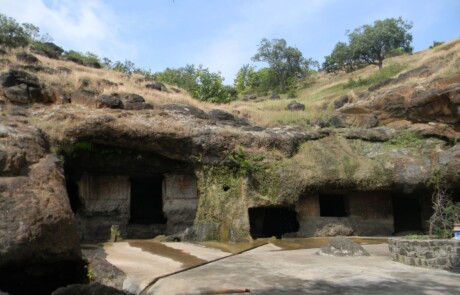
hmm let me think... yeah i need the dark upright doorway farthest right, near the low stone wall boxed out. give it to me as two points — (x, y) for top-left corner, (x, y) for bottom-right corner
(392, 193), (422, 233)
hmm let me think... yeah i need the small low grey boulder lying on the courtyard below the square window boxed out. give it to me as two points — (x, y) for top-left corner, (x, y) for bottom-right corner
(316, 236), (369, 257)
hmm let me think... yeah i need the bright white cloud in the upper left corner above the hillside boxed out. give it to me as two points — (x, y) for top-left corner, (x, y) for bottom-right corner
(2, 0), (136, 58)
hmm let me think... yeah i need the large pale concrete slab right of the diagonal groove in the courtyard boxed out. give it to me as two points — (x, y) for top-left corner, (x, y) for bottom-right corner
(145, 245), (460, 295)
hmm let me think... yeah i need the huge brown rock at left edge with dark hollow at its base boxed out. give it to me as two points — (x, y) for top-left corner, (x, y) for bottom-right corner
(0, 119), (82, 294)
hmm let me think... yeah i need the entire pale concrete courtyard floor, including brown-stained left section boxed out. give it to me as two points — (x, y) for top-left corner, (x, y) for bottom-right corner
(91, 241), (460, 295)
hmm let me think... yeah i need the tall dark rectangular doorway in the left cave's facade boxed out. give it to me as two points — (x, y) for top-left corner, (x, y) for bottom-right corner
(129, 176), (166, 224)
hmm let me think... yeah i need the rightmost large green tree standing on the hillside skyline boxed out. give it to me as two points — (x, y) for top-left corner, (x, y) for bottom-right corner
(348, 17), (413, 69)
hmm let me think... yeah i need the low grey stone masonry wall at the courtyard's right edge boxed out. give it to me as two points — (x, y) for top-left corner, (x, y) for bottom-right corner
(388, 238), (460, 271)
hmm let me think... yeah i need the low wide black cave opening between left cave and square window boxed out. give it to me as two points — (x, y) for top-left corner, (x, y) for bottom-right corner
(248, 207), (299, 239)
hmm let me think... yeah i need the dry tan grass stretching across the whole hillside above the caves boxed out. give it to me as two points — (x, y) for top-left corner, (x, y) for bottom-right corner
(0, 39), (460, 126)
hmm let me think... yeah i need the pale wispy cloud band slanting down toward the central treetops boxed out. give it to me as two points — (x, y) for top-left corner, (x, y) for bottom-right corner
(192, 0), (333, 84)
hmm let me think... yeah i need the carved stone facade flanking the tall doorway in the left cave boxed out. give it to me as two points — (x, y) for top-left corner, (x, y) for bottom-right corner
(76, 173), (198, 241)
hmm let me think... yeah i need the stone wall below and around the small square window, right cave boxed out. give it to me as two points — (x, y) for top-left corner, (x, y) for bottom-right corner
(296, 192), (394, 237)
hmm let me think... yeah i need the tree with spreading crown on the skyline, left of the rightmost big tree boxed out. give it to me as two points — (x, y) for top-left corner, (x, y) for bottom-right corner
(252, 38), (318, 92)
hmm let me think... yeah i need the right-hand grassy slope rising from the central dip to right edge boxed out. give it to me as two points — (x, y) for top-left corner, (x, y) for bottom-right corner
(223, 39), (460, 126)
